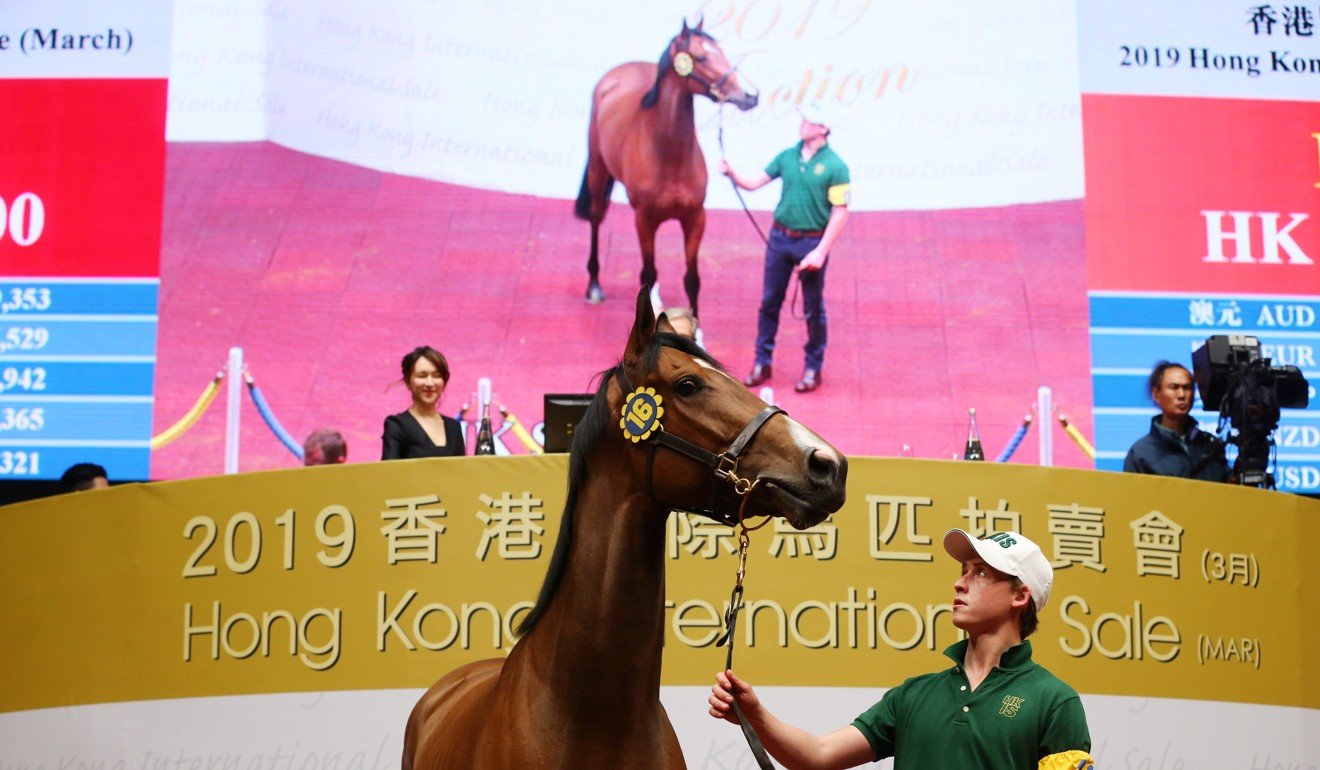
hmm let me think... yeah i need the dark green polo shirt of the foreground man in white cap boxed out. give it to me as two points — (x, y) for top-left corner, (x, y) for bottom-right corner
(853, 639), (1093, 770)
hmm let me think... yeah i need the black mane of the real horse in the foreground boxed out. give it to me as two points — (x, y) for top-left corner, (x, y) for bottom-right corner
(517, 332), (723, 637)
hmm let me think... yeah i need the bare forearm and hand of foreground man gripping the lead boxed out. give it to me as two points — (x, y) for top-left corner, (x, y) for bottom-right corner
(709, 671), (875, 770)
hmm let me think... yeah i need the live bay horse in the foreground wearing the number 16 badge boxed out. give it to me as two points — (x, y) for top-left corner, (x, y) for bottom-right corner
(403, 287), (847, 770)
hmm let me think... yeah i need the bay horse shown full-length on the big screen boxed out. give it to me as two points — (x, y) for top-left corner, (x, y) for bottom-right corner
(576, 20), (756, 318)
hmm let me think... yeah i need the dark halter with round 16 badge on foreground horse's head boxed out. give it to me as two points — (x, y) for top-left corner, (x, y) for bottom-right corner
(615, 363), (787, 530)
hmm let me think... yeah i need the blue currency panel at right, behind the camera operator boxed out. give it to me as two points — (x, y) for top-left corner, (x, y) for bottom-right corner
(1090, 292), (1320, 494)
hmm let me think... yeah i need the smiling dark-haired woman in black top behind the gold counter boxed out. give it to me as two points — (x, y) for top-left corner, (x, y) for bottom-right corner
(380, 345), (466, 460)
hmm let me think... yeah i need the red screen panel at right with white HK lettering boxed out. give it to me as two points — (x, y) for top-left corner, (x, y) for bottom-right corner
(1082, 95), (1320, 295)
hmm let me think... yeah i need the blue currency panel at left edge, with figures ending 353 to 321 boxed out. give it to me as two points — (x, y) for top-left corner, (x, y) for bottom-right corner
(0, 279), (158, 481)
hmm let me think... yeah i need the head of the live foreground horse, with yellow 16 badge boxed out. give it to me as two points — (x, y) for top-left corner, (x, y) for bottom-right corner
(605, 288), (847, 530)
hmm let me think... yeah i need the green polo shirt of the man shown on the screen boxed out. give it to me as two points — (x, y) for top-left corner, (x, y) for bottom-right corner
(766, 141), (853, 230)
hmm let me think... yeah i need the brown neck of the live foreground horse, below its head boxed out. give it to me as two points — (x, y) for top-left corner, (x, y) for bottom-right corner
(535, 446), (664, 703)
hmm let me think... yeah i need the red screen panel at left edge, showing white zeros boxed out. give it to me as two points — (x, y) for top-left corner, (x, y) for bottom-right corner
(0, 79), (168, 277)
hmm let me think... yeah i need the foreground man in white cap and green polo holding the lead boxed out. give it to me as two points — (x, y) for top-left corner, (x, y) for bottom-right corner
(710, 530), (1094, 770)
